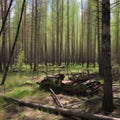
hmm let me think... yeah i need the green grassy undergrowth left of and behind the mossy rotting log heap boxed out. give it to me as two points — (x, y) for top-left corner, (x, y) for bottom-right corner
(0, 64), (102, 99)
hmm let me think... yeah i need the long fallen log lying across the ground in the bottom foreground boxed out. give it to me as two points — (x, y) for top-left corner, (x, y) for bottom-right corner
(0, 95), (120, 120)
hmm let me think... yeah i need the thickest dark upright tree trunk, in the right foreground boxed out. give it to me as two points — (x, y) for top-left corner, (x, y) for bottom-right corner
(102, 0), (113, 112)
